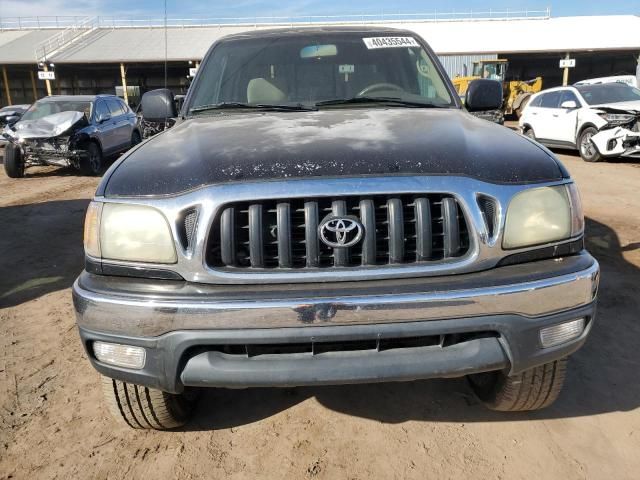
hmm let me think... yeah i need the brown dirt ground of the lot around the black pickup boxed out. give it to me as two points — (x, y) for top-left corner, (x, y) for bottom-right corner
(0, 148), (640, 480)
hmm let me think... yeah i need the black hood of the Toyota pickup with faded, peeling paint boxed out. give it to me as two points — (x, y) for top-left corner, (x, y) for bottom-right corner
(98, 108), (568, 196)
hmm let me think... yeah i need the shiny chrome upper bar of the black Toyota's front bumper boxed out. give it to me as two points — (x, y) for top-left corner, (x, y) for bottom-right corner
(73, 254), (599, 337)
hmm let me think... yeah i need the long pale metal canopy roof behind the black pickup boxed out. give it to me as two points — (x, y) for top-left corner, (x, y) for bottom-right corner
(0, 12), (640, 65)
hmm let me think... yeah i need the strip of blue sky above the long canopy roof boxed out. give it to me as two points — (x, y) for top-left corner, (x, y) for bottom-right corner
(0, 0), (640, 18)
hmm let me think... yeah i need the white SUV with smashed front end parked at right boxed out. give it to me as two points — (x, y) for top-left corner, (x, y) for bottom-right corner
(520, 83), (640, 162)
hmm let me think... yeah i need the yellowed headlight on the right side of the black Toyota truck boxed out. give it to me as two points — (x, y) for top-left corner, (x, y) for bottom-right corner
(502, 183), (584, 249)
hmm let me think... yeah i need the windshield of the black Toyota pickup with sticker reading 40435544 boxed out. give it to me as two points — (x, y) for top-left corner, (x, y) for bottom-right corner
(188, 32), (455, 114)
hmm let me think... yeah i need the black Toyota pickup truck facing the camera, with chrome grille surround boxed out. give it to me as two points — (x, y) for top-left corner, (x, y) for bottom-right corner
(73, 27), (599, 429)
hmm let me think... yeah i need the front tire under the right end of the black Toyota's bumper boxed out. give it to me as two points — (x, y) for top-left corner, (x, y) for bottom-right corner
(467, 358), (567, 412)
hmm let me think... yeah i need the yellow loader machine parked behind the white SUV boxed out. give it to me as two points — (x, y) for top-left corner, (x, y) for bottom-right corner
(453, 59), (542, 118)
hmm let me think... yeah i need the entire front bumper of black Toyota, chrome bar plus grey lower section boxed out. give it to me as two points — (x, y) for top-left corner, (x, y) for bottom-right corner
(73, 253), (599, 392)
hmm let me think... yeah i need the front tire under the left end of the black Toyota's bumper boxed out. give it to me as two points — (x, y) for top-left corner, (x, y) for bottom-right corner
(102, 376), (197, 430)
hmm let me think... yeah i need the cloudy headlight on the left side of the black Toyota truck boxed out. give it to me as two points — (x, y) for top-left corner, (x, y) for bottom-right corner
(85, 202), (177, 263)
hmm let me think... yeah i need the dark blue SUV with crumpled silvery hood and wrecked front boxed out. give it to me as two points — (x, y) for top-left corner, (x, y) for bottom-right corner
(2, 95), (141, 178)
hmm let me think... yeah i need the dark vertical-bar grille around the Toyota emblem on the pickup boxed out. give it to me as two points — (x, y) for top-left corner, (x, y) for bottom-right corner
(206, 194), (469, 271)
